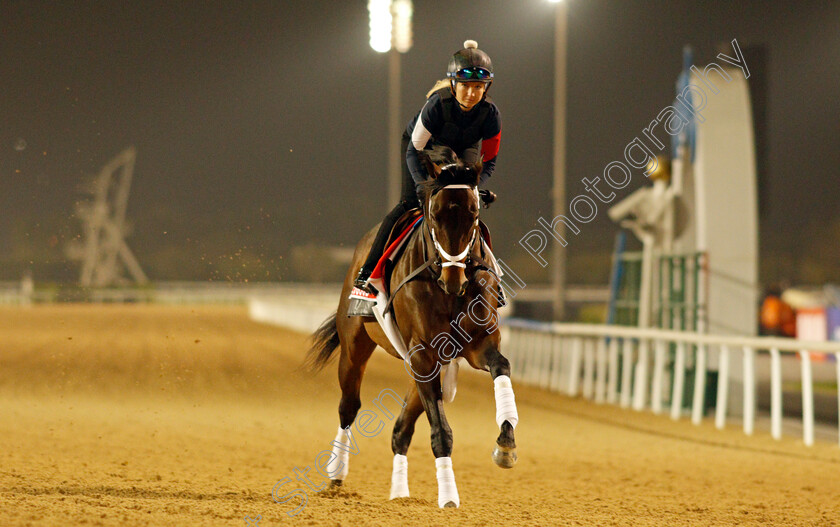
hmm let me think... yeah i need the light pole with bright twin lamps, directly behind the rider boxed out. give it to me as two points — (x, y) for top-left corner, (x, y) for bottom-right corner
(368, 0), (413, 210)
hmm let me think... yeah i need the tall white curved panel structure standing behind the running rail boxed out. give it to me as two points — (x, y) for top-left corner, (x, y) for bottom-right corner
(677, 68), (759, 335)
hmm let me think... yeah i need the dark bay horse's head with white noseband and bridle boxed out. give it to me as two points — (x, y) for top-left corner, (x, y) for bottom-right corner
(420, 147), (481, 296)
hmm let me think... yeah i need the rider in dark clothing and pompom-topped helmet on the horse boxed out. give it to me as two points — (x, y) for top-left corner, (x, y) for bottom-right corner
(354, 40), (502, 291)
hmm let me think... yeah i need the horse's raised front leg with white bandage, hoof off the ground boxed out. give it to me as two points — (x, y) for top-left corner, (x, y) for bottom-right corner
(485, 347), (519, 468)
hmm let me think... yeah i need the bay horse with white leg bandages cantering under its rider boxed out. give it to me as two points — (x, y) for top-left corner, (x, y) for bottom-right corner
(307, 147), (519, 507)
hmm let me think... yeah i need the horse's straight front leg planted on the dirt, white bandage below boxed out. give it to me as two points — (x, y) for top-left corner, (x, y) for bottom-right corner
(412, 347), (461, 508)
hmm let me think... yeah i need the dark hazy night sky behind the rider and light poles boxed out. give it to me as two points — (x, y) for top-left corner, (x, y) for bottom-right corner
(0, 0), (840, 283)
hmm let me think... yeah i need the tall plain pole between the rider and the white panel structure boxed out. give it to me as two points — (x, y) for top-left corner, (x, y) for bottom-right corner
(549, 0), (568, 321)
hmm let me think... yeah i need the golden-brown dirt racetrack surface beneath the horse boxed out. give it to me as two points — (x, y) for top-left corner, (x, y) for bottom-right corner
(0, 305), (840, 527)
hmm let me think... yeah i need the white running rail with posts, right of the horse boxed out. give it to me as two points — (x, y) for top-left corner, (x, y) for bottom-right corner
(502, 319), (840, 446)
